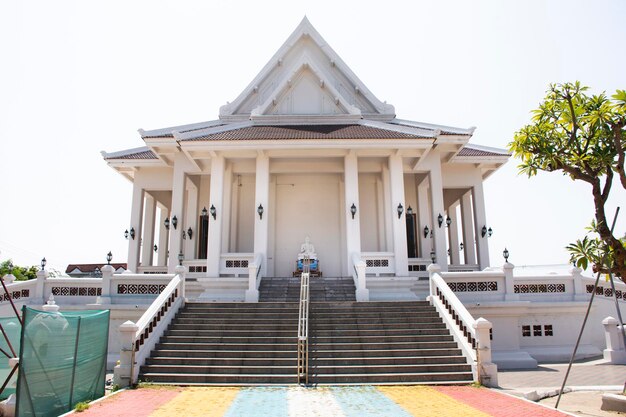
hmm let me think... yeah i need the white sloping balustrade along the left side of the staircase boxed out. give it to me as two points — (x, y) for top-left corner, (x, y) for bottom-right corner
(130, 274), (185, 385)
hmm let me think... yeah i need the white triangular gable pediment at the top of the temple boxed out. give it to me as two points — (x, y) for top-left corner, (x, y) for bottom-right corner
(220, 17), (395, 120)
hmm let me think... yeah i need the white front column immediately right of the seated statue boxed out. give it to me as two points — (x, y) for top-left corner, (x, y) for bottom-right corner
(344, 152), (361, 274)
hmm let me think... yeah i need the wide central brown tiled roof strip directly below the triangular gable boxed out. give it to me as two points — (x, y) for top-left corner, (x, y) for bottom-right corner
(186, 125), (426, 141)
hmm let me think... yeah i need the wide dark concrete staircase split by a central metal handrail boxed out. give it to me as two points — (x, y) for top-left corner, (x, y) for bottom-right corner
(140, 277), (472, 385)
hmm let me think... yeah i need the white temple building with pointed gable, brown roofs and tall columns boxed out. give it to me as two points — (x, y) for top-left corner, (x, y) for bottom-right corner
(103, 18), (509, 300)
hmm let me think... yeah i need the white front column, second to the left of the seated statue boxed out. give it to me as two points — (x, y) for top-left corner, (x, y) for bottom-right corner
(207, 155), (225, 277)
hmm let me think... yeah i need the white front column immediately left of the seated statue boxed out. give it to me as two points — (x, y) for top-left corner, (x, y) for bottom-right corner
(250, 151), (273, 276)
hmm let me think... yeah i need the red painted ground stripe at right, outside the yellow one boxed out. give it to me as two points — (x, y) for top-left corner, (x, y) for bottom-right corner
(435, 386), (569, 417)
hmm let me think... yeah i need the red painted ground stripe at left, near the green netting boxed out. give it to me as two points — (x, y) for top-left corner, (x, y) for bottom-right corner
(76, 388), (182, 417)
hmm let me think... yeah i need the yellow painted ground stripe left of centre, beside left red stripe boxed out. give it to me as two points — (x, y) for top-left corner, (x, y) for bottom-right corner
(150, 387), (239, 417)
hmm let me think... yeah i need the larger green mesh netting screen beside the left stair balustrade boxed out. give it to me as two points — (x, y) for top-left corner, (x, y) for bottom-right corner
(16, 306), (109, 417)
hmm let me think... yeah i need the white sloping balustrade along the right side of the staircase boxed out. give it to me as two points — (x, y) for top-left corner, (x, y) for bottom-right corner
(430, 273), (477, 362)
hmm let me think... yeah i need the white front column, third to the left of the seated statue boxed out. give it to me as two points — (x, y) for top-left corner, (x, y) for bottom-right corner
(167, 154), (186, 274)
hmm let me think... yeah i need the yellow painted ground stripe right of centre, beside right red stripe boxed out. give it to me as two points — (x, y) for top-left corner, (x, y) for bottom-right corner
(377, 386), (489, 417)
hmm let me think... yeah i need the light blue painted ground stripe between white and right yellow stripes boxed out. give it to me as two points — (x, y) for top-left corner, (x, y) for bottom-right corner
(330, 386), (412, 417)
